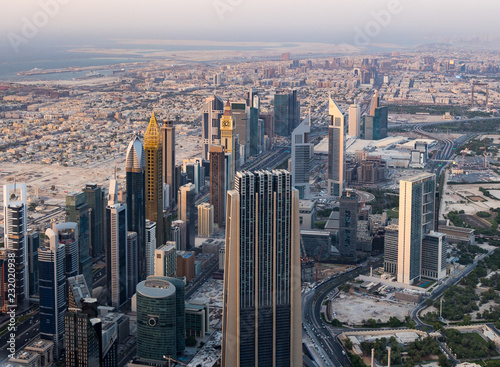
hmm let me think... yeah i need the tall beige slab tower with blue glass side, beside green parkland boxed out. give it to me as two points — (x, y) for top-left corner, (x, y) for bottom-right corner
(397, 173), (436, 284)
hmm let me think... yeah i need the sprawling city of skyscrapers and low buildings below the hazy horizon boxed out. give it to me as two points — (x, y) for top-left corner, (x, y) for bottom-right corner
(0, 46), (500, 367)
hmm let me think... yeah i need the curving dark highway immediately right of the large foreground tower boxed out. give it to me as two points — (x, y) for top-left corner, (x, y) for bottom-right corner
(302, 260), (381, 366)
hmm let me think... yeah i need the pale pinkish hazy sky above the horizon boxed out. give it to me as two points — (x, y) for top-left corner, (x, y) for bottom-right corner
(0, 0), (500, 51)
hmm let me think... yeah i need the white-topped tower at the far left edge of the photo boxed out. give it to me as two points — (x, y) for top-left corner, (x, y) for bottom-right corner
(3, 183), (29, 305)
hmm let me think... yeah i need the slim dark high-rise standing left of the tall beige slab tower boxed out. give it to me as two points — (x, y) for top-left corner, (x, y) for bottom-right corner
(338, 189), (359, 262)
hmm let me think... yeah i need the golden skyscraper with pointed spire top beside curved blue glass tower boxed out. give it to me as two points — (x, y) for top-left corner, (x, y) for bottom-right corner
(144, 112), (165, 247)
